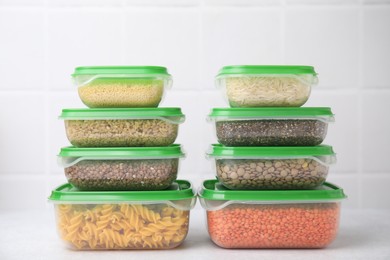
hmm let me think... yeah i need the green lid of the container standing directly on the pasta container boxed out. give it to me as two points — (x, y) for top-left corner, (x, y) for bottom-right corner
(58, 144), (184, 159)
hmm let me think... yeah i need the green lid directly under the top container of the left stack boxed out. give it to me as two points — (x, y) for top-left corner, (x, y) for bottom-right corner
(59, 107), (185, 124)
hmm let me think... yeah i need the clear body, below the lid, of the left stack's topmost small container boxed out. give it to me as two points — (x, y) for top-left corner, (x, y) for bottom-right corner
(75, 75), (171, 108)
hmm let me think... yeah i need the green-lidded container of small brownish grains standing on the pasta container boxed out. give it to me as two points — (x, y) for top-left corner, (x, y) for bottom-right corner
(58, 145), (184, 191)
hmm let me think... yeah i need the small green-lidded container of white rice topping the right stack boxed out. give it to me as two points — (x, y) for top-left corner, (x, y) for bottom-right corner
(216, 65), (318, 107)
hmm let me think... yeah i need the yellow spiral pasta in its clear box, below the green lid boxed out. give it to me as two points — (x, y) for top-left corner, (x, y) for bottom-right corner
(56, 204), (189, 249)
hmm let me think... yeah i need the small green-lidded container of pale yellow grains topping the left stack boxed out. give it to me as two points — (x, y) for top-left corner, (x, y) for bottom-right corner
(72, 66), (172, 108)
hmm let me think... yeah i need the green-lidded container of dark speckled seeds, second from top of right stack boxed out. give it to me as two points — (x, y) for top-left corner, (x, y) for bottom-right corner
(209, 107), (334, 146)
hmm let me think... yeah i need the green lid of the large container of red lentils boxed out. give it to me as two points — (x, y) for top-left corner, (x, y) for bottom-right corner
(199, 180), (347, 202)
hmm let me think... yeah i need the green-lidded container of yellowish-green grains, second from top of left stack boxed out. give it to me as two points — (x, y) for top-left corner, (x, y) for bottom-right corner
(60, 108), (185, 147)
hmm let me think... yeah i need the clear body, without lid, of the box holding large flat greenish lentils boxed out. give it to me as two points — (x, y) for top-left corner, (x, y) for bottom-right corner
(215, 158), (329, 190)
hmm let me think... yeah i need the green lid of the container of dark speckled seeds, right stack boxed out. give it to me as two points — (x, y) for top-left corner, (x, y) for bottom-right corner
(209, 107), (334, 121)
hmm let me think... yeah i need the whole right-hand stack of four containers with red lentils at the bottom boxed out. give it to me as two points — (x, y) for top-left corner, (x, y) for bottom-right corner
(199, 66), (345, 248)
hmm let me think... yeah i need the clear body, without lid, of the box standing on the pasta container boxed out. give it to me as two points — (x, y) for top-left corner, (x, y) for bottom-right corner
(64, 158), (179, 191)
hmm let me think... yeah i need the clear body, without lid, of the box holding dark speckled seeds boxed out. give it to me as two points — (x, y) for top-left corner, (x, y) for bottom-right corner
(215, 118), (328, 146)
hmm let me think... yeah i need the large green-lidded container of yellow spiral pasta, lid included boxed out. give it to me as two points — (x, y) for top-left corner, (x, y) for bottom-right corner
(49, 180), (196, 250)
